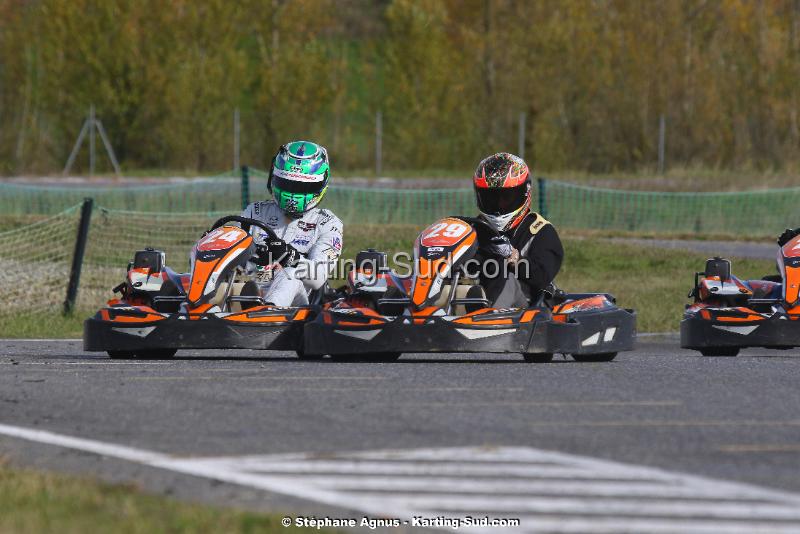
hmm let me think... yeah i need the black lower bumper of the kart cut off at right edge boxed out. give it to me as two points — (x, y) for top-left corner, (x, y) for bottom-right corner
(681, 313), (800, 350)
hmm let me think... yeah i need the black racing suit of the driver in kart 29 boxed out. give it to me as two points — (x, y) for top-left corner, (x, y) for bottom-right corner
(468, 212), (564, 308)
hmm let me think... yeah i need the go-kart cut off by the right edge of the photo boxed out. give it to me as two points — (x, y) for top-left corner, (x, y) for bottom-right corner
(681, 236), (800, 356)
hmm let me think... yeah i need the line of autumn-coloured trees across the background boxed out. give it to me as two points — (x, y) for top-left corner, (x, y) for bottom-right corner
(0, 0), (800, 174)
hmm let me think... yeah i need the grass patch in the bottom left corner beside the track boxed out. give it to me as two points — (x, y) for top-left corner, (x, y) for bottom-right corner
(0, 465), (331, 534)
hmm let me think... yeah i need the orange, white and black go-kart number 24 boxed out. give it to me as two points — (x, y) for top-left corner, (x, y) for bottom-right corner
(83, 215), (321, 358)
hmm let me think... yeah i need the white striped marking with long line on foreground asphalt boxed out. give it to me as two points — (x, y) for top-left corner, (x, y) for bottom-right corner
(0, 424), (800, 534)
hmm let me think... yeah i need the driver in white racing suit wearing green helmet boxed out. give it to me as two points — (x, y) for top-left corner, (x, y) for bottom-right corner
(242, 141), (343, 306)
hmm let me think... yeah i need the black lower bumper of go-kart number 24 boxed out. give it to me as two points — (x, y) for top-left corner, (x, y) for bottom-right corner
(83, 314), (303, 351)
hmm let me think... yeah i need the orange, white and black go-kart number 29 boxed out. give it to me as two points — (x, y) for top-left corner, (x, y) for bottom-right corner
(304, 217), (636, 362)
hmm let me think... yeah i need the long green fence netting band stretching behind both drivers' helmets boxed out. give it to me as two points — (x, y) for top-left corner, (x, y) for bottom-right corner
(0, 169), (800, 236)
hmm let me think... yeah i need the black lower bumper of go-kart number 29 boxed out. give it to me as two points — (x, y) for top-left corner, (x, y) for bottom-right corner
(304, 309), (636, 355)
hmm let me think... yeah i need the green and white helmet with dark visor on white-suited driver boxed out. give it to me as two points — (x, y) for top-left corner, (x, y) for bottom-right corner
(267, 141), (330, 215)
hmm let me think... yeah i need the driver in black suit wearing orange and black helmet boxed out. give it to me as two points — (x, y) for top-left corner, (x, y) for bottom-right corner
(473, 152), (564, 308)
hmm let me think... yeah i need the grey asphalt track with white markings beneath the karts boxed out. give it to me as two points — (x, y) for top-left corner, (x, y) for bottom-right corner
(0, 338), (800, 532)
